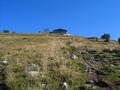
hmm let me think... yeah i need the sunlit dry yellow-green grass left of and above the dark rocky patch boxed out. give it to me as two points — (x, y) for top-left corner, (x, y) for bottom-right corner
(0, 34), (120, 90)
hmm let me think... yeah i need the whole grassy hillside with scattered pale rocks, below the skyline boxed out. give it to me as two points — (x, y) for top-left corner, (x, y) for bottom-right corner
(0, 34), (120, 90)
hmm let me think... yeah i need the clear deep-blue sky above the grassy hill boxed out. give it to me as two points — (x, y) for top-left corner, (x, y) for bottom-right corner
(0, 0), (120, 39)
